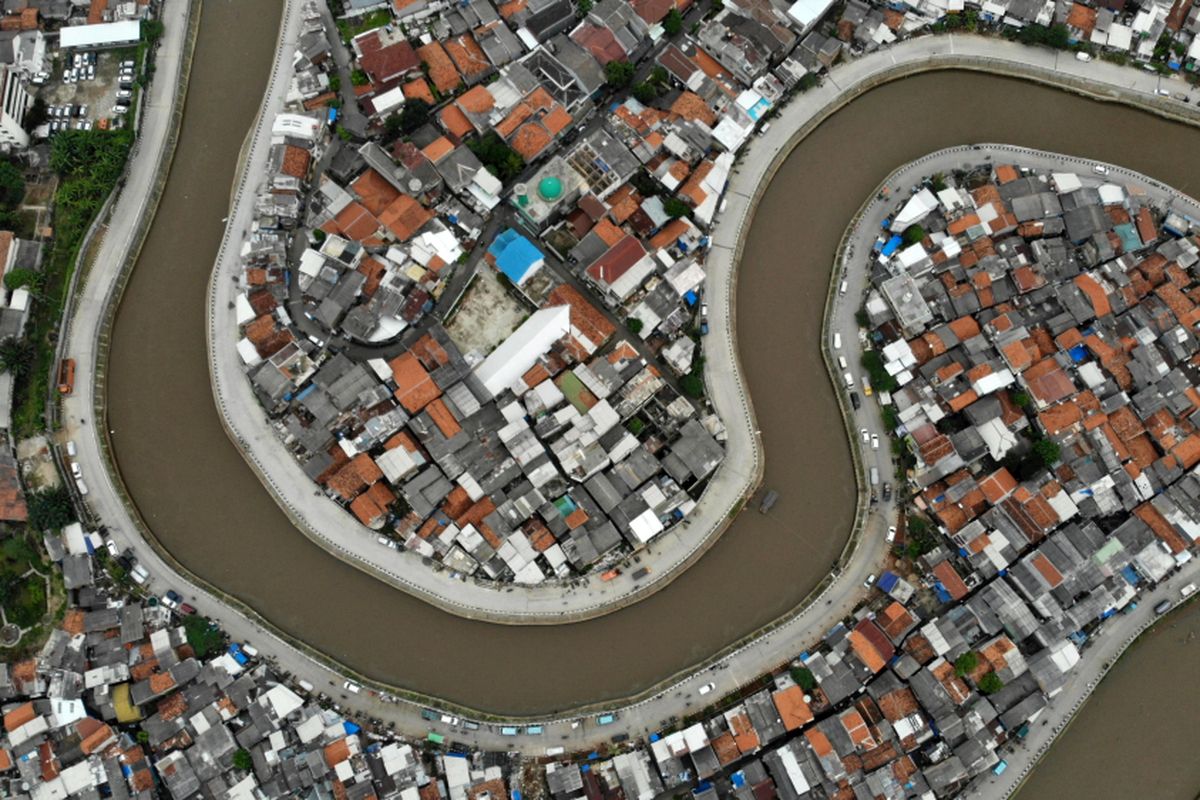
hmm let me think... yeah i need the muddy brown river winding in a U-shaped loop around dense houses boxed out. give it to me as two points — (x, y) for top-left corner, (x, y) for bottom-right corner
(109, 0), (1200, 782)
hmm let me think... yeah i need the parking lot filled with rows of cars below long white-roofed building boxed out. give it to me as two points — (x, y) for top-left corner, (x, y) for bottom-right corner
(37, 49), (134, 136)
